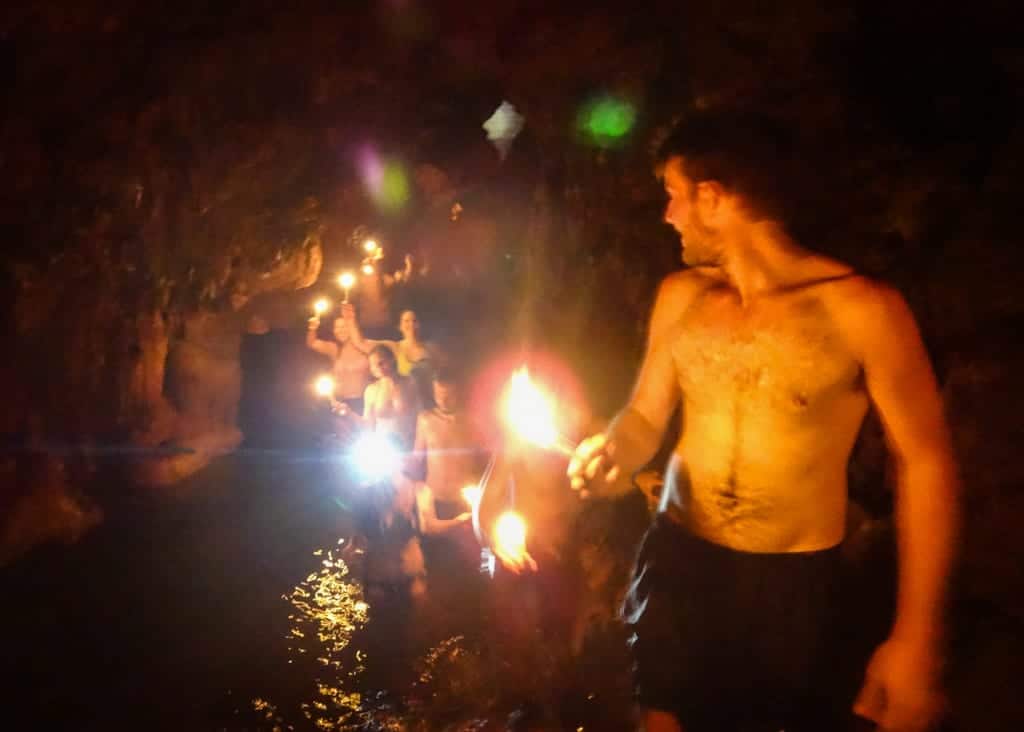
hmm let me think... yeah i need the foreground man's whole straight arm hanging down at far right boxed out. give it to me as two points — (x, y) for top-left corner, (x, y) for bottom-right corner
(843, 283), (959, 729)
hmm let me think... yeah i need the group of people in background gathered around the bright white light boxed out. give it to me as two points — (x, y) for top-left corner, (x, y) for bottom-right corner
(306, 303), (485, 601)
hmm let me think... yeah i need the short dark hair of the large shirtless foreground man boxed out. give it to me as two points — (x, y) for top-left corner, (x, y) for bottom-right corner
(656, 110), (799, 222)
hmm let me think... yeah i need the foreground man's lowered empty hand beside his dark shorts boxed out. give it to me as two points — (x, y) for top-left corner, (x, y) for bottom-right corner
(853, 638), (945, 732)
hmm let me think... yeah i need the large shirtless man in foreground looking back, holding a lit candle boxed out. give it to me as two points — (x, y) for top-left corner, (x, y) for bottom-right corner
(569, 114), (958, 732)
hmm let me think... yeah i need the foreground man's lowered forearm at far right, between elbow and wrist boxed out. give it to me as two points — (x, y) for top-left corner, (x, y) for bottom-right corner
(892, 459), (961, 647)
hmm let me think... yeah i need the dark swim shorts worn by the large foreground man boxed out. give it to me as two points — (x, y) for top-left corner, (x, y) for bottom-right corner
(623, 515), (850, 732)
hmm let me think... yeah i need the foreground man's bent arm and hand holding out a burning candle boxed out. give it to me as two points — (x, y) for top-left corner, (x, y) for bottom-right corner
(568, 271), (695, 494)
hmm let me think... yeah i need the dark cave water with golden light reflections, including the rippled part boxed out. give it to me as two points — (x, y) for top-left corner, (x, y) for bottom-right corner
(0, 448), (628, 731)
